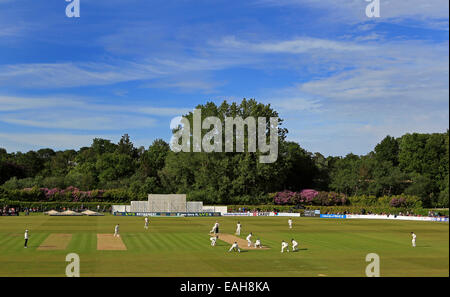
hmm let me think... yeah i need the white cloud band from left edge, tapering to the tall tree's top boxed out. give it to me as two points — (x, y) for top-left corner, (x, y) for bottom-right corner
(0, 95), (191, 131)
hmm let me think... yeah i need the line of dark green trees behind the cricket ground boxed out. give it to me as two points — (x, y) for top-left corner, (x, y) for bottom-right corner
(0, 99), (449, 207)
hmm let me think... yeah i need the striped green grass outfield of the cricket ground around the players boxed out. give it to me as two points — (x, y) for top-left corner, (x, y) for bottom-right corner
(0, 215), (449, 277)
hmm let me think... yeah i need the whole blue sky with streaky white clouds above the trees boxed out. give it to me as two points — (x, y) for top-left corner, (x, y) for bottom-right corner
(0, 0), (449, 156)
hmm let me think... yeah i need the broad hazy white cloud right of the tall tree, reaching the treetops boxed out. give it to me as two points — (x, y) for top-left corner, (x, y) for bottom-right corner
(255, 37), (449, 155)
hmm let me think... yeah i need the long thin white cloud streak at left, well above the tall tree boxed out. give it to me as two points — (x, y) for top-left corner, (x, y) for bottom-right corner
(0, 57), (245, 89)
